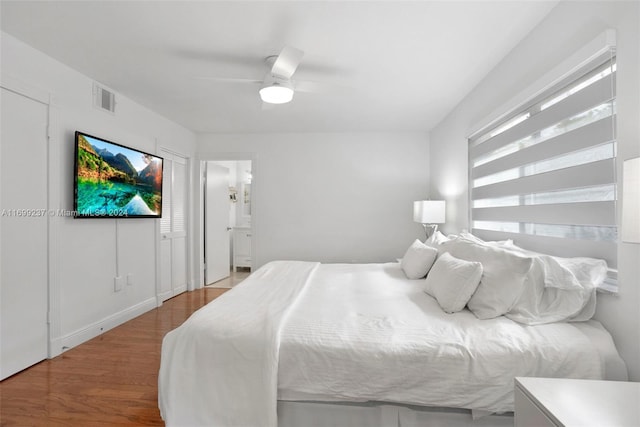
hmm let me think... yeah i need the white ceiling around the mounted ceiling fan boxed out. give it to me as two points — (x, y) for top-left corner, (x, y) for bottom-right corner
(1, 0), (557, 133)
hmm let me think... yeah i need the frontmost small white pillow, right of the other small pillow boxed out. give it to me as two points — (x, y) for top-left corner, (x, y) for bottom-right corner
(424, 253), (482, 313)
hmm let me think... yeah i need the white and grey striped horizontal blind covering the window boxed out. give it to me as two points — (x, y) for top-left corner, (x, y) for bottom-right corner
(469, 52), (618, 267)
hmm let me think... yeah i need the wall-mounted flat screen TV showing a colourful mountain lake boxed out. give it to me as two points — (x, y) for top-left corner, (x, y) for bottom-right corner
(73, 131), (163, 218)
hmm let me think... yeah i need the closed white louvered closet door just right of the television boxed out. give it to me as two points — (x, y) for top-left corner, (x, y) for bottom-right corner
(158, 150), (188, 301)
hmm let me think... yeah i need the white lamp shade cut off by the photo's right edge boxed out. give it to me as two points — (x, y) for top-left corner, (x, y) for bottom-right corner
(622, 157), (640, 243)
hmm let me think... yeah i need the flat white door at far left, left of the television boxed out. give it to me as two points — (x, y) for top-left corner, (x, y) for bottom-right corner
(0, 88), (48, 380)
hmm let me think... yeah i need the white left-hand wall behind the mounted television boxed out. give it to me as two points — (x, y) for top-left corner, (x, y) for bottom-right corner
(1, 33), (195, 355)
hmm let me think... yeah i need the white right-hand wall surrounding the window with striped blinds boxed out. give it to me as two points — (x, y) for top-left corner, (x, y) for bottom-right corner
(430, 2), (640, 381)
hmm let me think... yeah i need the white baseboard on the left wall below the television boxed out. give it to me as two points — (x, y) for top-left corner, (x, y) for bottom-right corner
(50, 297), (157, 357)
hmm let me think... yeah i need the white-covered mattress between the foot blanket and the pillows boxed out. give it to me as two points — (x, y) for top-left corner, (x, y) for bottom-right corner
(278, 263), (626, 413)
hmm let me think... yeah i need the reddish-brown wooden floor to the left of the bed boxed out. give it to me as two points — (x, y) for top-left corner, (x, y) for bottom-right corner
(0, 287), (229, 426)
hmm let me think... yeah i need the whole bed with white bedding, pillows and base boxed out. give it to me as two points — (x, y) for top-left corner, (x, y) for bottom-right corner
(159, 236), (626, 426)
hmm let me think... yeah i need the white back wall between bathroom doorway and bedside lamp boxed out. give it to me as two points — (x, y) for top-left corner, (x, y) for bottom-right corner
(198, 133), (429, 267)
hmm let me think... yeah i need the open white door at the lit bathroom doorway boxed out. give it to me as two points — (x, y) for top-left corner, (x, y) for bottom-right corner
(204, 162), (231, 285)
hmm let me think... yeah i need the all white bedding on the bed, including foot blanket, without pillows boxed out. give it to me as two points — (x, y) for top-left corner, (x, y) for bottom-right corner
(159, 262), (602, 426)
